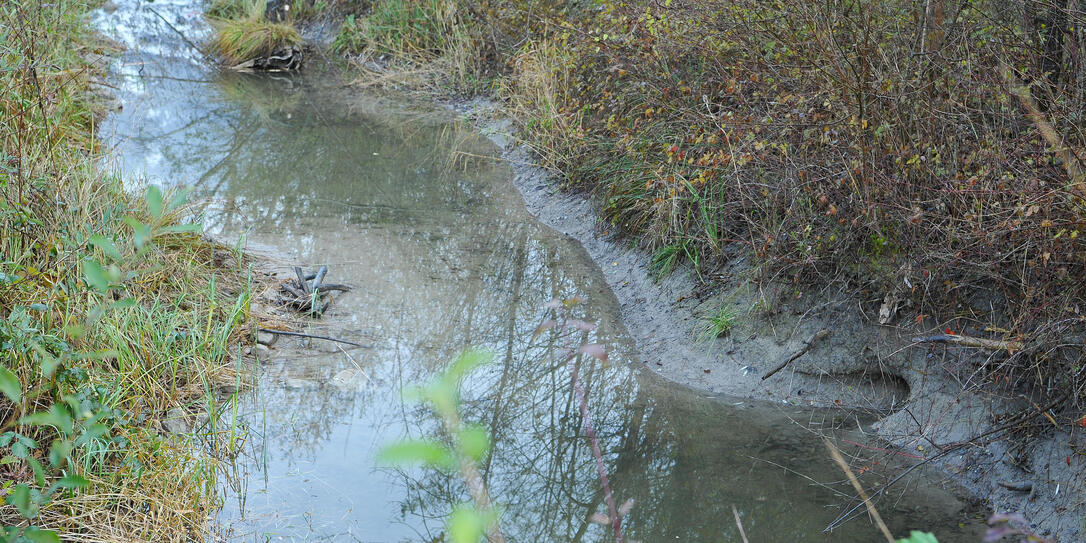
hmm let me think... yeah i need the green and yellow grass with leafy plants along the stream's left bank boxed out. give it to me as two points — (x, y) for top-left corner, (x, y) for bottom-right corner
(0, 0), (250, 542)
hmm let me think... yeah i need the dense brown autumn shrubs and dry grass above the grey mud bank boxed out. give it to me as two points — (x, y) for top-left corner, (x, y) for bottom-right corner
(336, 0), (1086, 430)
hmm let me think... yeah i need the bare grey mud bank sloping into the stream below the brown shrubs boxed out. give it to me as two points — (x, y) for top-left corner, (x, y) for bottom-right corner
(454, 101), (1086, 542)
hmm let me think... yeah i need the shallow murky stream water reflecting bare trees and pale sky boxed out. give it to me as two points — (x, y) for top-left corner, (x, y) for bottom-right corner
(96, 0), (978, 542)
